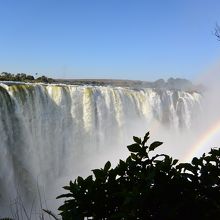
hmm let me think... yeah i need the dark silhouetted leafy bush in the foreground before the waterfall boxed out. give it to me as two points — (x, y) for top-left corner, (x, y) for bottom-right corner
(58, 132), (220, 220)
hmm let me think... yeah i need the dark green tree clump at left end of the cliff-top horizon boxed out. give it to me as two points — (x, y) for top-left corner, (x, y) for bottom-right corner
(0, 72), (55, 83)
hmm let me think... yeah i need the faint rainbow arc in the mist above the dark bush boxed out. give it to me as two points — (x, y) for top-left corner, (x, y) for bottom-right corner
(184, 120), (220, 161)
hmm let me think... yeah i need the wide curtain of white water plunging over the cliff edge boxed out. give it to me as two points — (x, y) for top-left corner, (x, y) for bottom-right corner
(0, 83), (201, 217)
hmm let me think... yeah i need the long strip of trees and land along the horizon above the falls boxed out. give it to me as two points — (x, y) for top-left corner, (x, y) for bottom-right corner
(0, 72), (205, 92)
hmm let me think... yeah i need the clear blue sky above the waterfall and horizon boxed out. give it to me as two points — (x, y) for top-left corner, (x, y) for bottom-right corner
(0, 0), (220, 80)
